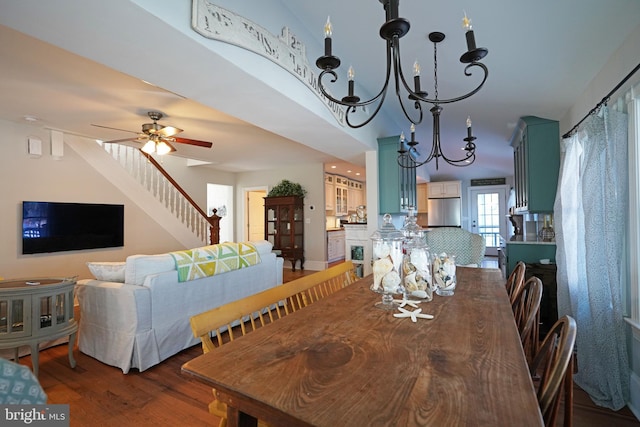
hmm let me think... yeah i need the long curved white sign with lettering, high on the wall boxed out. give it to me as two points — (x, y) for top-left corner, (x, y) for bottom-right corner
(191, 0), (345, 126)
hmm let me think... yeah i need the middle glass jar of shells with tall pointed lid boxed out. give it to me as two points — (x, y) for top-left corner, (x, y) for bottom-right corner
(402, 207), (433, 301)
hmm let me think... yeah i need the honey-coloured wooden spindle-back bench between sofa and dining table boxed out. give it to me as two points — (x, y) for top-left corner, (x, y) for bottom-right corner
(190, 261), (358, 427)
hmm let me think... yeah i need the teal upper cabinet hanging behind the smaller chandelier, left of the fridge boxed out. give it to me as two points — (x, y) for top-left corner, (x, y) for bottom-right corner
(378, 135), (417, 214)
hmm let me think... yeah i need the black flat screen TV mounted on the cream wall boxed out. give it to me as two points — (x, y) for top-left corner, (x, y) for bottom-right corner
(22, 201), (124, 254)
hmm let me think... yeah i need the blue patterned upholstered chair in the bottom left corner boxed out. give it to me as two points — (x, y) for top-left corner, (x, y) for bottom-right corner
(0, 358), (47, 405)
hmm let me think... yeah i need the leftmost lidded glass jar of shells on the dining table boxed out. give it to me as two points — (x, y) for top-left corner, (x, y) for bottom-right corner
(371, 214), (404, 310)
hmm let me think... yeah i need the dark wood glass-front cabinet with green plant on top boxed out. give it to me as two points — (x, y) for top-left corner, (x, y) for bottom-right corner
(264, 196), (304, 271)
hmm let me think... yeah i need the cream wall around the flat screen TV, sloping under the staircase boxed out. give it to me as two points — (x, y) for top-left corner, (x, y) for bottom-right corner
(0, 121), (188, 278)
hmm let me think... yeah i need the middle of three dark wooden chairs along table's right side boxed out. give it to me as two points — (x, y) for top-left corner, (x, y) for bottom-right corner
(511, 276), (542, 363)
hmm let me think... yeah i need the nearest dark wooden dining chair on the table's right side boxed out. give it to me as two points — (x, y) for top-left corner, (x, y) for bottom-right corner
(529, 315), (577, 427)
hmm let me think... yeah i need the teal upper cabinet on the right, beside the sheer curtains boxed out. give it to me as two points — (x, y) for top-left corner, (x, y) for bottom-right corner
(511, 116), (560, 213)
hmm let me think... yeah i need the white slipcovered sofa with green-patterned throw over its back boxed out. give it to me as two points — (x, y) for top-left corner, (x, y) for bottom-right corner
(76, 241), (283, 374)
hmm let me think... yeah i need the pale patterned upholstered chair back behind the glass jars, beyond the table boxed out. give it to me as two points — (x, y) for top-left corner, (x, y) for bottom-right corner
(426, 227), (486, 267)
